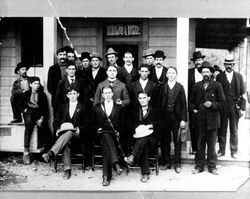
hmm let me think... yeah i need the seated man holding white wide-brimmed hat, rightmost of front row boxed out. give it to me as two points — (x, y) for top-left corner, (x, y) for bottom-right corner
(124, 91), (160, 182)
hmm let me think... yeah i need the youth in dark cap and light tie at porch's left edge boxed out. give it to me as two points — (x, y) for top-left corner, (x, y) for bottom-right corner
(18, 77), (49, 164)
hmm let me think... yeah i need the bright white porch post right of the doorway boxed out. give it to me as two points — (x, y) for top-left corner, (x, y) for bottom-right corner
(176, 18), (191, 152)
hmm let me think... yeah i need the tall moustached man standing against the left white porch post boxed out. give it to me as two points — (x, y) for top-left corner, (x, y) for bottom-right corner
(47, 48), (66, 120)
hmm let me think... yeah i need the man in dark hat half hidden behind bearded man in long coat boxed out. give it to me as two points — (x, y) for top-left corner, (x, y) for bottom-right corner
(188, 51), (205, 155)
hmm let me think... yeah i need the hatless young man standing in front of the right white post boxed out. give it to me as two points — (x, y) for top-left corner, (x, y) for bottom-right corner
(160, 66), (187, 173)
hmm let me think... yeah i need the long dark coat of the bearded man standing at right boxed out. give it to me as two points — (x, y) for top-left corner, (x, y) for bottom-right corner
(189, 80), (226, 130)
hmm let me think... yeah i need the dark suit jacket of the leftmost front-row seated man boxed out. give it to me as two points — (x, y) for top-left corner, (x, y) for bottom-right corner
(55, 102), (89, 137)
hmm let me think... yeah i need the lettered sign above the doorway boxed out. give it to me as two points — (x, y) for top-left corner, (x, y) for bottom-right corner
(106, 25), (141, 37)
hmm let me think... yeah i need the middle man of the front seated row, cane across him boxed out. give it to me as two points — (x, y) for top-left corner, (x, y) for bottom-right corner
(93, 86), (122, 186)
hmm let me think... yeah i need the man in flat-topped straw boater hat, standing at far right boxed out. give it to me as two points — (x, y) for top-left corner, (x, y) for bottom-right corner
(216, 55), (246, 159)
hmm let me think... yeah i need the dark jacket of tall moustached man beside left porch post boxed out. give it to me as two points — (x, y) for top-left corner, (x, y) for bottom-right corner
(47, 64), (62, 107)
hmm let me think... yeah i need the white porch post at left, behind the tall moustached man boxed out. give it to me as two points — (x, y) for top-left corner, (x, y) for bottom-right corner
(43, 17), (57, 127)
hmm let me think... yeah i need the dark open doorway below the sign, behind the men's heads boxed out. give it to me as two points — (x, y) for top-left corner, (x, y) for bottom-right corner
(105, 43), (139, 67)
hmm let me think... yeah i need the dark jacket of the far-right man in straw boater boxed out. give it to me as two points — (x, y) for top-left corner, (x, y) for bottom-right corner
(216, 71), (246, 110)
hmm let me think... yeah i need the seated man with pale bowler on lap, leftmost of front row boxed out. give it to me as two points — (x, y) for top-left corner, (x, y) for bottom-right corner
(42, 85), (88, 179)
